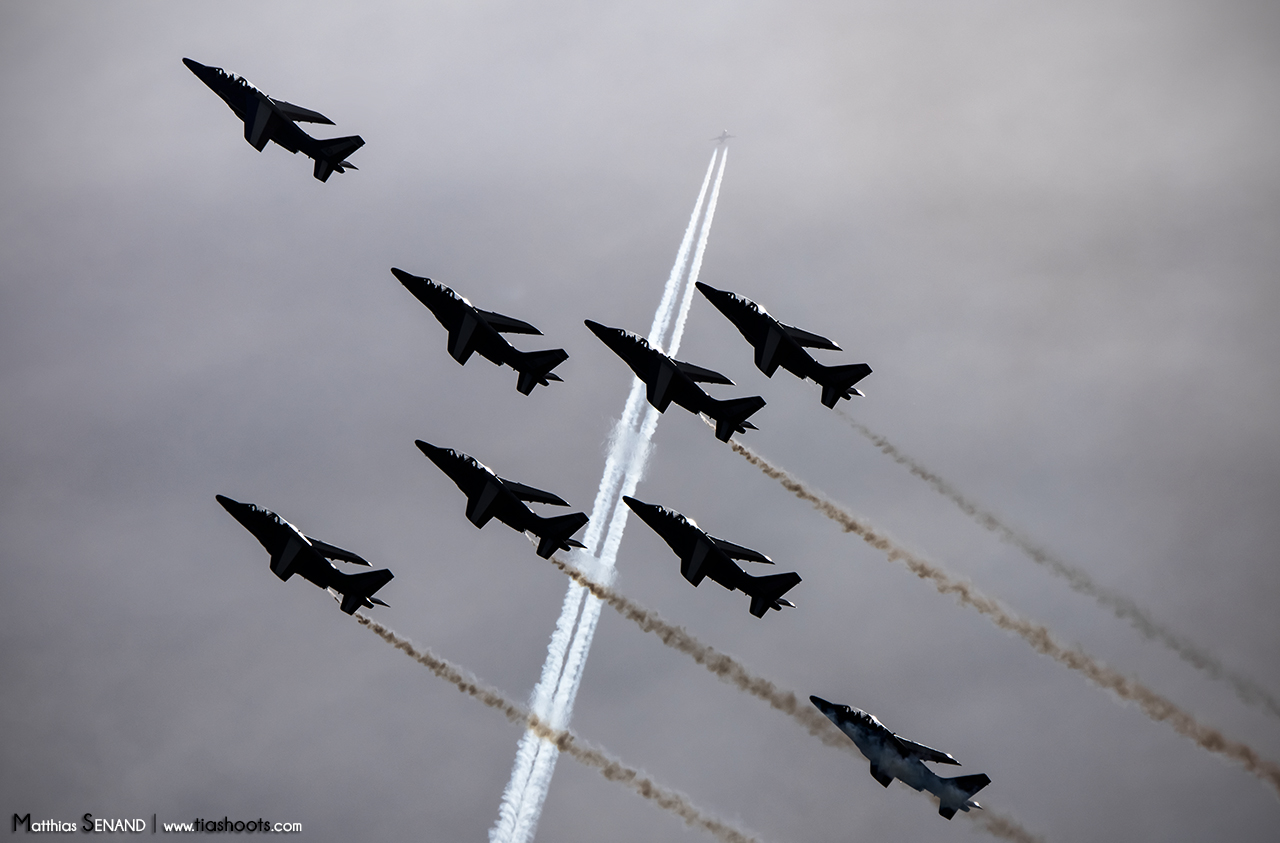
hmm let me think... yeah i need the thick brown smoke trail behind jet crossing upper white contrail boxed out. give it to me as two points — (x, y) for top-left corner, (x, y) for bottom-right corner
(730, 440), (1280, 796)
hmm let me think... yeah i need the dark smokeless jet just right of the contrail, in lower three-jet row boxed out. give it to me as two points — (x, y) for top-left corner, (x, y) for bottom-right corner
(622, 495), (800, 618)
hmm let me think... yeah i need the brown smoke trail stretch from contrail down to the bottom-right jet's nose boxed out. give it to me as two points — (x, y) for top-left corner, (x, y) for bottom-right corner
(550, 556), (860, 757)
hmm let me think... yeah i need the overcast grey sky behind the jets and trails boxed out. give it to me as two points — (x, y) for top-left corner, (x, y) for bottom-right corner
(0, 0), (1280, 843)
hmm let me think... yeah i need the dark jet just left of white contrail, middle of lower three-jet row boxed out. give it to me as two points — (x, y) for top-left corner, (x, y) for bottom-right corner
(413, 439), (589, 559)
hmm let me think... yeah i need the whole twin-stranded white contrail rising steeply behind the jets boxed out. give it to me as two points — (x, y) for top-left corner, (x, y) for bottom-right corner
(489, 152), (723, 843)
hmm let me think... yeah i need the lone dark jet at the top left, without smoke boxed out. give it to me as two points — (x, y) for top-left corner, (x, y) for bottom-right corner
(182, 59), (365, 182)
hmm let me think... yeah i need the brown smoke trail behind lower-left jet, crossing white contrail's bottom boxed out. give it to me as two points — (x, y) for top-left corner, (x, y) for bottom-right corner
(356, 614), (760, 843)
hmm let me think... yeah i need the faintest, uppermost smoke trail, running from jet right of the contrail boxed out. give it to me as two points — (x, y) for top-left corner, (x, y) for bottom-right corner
(836, 409), (1280, 718)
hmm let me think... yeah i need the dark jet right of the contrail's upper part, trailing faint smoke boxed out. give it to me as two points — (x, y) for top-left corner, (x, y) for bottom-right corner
(698, 281), (872, 407)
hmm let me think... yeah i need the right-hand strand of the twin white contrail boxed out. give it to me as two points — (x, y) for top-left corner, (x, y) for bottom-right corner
(513, 150), (728, 842)
